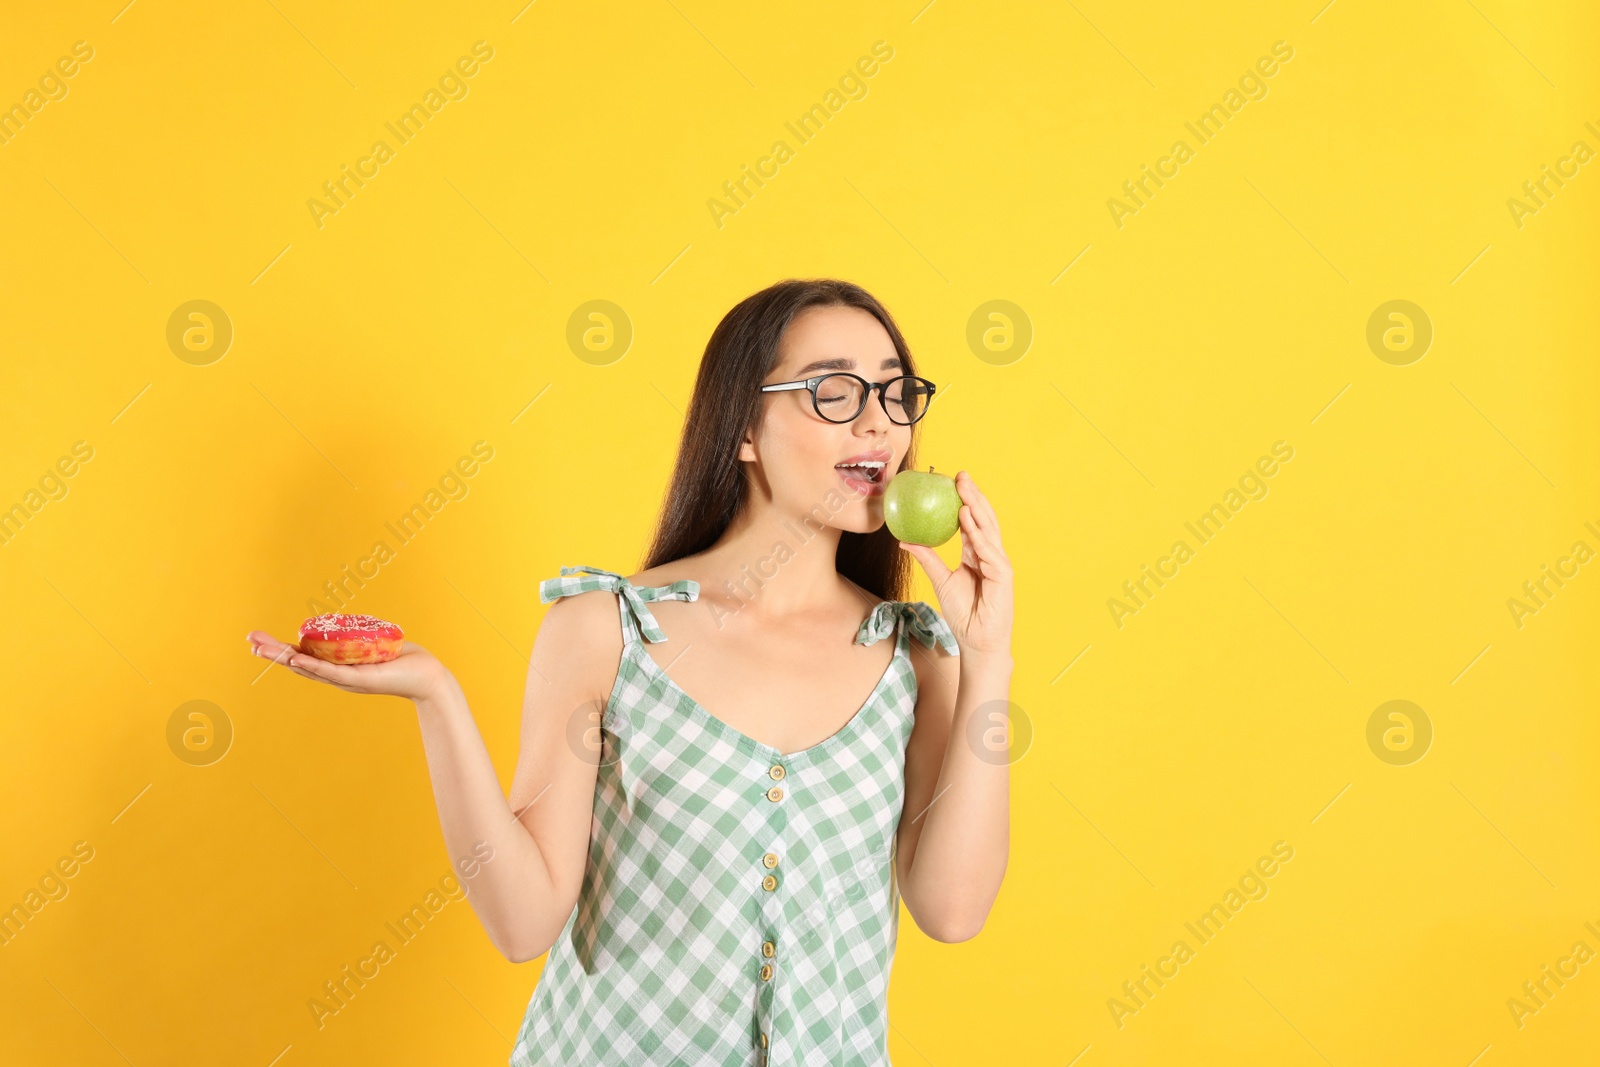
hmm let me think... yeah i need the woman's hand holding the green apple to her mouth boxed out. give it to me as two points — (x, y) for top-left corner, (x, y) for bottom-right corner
(899, 470), (1013, 656)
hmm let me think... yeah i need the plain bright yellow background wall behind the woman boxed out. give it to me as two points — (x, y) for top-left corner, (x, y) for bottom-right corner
(0, 0), (1600, 1067)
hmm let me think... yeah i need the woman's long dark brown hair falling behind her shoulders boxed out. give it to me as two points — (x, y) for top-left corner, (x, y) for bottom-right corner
(640, 278), (917, 600)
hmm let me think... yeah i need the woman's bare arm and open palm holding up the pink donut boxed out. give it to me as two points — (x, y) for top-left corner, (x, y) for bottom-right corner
(250, 595), (622, 963)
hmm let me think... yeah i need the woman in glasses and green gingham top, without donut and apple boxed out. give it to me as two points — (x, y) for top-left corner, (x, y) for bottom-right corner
(250, 280), (1013, 1067)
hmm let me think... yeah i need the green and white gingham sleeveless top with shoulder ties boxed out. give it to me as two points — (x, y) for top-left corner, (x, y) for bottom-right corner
(510, 566), (958, 1067)
